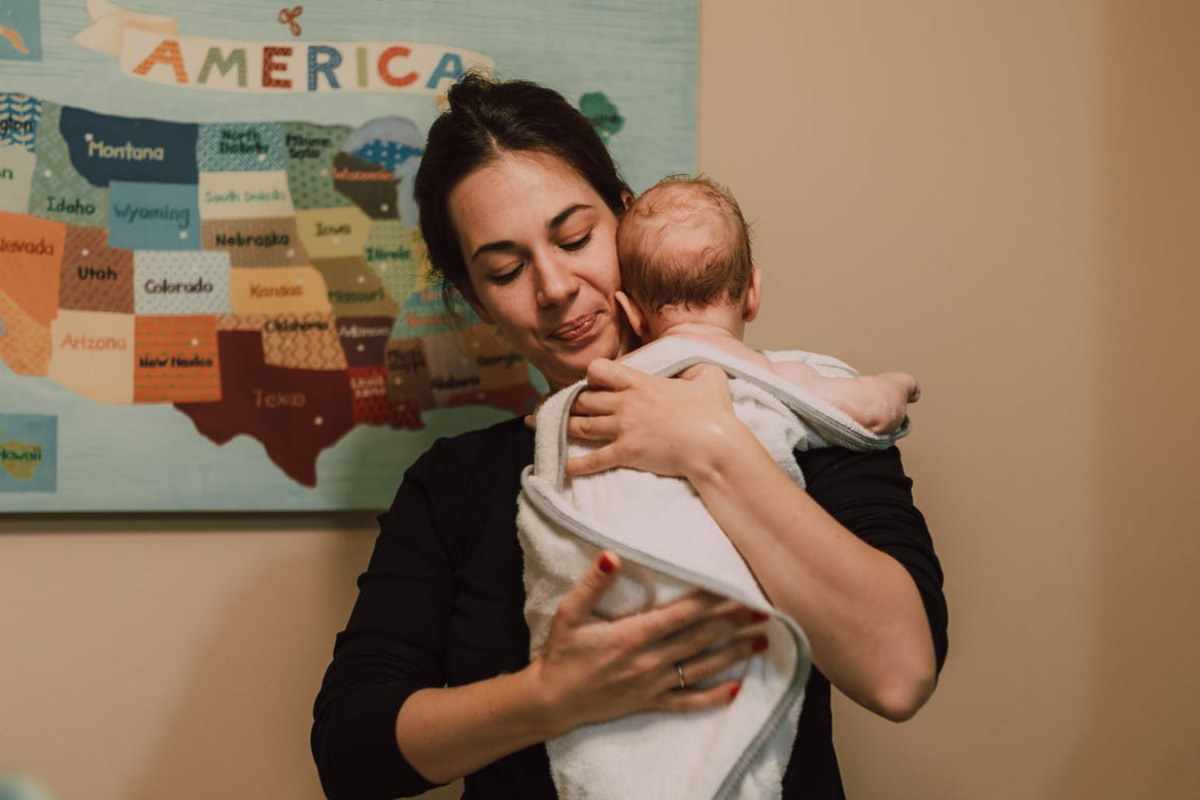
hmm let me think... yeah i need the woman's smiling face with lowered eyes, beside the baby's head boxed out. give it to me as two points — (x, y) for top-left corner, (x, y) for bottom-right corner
(449, 152), (620, 389)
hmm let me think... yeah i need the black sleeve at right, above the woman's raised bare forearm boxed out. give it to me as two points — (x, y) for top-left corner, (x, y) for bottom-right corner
(796, 447), (949, 669)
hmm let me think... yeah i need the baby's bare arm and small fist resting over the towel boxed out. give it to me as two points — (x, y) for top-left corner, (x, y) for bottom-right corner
(772, 361), (920, 433)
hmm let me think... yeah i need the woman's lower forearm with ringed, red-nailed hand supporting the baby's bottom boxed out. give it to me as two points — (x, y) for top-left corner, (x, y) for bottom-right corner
(396, 551), (762, 783)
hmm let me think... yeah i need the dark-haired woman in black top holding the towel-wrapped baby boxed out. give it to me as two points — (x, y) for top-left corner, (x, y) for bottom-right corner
(312, 76), (946, 800)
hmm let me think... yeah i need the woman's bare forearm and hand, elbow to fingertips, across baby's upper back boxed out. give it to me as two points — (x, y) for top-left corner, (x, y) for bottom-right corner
(566, 359), (937, 720)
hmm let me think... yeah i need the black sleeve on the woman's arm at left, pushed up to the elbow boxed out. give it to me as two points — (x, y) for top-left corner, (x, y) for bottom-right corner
(311, 445), (454, 800)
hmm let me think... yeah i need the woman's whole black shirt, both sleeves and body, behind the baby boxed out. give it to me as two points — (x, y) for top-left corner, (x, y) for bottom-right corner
(312, 420), (947, 800)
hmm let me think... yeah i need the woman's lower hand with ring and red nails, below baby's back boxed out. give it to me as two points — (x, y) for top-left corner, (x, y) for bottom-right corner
(532, 552), (767, 732)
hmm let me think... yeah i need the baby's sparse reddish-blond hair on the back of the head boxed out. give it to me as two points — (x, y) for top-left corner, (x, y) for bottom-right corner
(617, 175), (754, 313)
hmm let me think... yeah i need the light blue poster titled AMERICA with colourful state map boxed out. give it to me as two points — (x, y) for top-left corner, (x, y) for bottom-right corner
(0, 0), (697, 512)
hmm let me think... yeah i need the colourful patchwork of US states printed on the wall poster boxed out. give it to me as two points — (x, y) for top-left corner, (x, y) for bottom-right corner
(0, 92), (538, 486)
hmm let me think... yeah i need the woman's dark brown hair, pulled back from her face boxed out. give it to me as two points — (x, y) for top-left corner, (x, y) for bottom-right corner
(413, 72), (629, 309)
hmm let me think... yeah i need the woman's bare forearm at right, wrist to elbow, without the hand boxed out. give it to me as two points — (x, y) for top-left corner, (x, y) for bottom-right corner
(686, 425), (937, 720)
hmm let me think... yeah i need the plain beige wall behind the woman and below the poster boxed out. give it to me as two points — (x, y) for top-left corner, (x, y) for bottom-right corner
(0, 0), (1200, 800)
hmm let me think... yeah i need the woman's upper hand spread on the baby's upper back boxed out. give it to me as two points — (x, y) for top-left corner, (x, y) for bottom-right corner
(566, 359), (752, 477)
